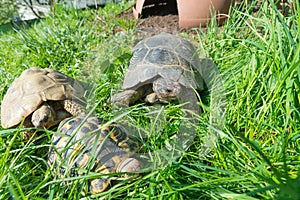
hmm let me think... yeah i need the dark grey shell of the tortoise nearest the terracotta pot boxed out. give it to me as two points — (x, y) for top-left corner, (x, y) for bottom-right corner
(123, 33), (203, 90)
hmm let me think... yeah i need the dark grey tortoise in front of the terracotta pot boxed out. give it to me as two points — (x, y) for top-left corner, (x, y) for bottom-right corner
(110, 33), (203, 113)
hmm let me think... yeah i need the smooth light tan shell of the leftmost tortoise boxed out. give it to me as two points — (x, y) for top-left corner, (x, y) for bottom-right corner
(1, 68), (86, 128)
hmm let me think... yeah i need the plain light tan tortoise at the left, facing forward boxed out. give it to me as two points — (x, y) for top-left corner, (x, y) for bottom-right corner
(1, 68), (86, 139)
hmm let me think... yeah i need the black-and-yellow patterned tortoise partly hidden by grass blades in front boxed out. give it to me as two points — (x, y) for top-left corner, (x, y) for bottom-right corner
(48, 116), (140, 194)
